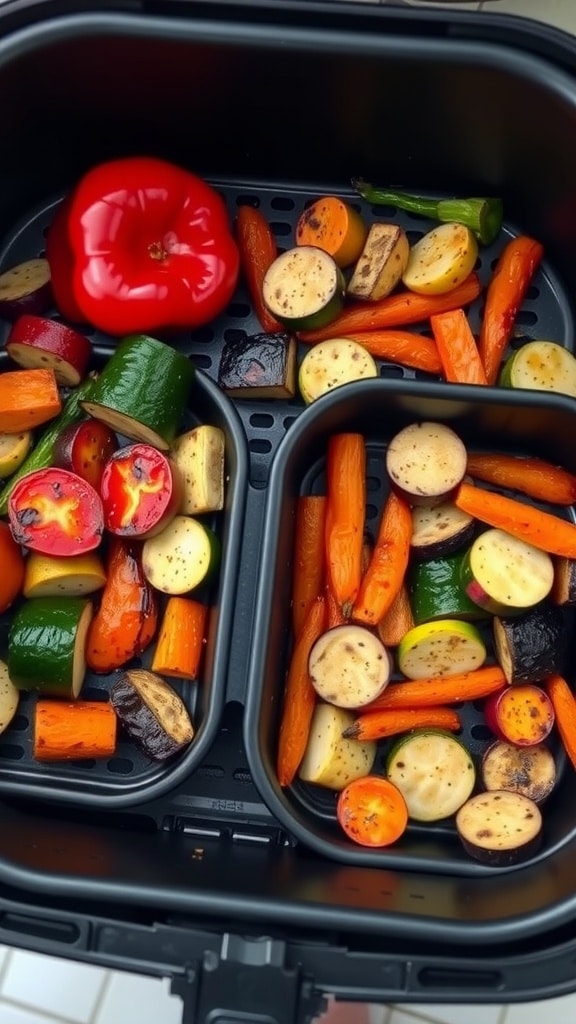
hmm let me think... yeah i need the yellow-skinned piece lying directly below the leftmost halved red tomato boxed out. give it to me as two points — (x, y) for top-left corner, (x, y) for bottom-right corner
(23, 551), (106, 597)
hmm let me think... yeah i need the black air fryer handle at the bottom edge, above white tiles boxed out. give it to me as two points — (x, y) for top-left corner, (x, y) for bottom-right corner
(172, 934), (326, 1024)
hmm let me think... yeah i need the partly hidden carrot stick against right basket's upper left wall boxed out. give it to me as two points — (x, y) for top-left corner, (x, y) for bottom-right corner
(292, 495), (327, 637)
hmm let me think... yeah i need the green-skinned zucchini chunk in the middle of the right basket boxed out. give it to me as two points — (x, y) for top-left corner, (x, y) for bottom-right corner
(410, 554), (487, 625)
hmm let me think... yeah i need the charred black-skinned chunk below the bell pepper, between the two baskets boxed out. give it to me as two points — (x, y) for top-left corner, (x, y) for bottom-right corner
(218, 332), (297, 398)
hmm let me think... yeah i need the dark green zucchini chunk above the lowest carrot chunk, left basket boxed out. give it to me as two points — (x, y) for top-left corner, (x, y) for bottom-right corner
(7, 597), (93, 700)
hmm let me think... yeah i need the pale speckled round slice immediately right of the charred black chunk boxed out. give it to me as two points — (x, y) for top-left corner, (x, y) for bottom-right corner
(298, 338), (378, 406)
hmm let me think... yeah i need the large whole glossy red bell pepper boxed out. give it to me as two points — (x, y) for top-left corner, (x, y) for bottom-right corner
(68, 157), (240, 337)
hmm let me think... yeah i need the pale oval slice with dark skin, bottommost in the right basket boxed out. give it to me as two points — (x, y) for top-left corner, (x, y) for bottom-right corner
(456, 790), (542, 867)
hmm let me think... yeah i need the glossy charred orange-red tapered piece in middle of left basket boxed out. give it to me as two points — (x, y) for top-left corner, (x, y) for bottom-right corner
(86, 537), (158, 672)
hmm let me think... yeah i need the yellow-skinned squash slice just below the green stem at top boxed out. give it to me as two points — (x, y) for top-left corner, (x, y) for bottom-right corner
(402, 223), (478, 295)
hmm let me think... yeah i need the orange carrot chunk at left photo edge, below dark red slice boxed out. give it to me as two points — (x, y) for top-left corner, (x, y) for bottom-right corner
(0, 370), (61, 434)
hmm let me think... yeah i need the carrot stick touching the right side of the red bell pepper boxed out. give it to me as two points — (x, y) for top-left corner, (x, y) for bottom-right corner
(231, 206), (282, 332)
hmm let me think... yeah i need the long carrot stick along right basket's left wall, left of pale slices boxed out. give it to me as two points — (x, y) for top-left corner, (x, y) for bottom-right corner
(278, 597), (326, 786)
